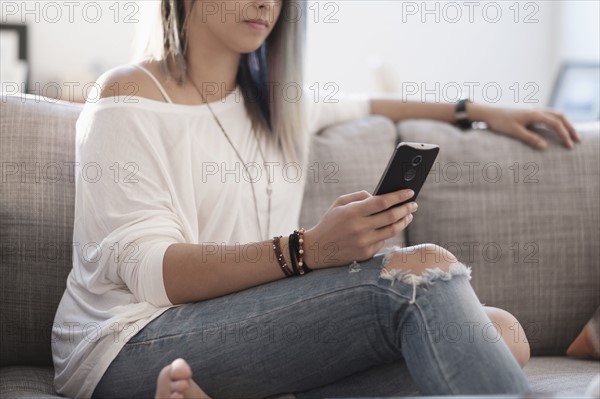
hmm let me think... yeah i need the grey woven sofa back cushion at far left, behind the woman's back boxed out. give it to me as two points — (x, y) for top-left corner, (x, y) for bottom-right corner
(0, 96), (81, 366)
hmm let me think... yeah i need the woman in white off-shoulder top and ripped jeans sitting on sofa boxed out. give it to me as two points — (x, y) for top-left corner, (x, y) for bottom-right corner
(53, 0), (579, 398)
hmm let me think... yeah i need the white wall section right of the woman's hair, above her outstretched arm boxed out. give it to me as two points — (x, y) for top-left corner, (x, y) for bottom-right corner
(309, 1), (568, 106)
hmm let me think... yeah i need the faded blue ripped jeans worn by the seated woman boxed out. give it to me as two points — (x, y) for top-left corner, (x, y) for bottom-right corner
(94, 250), (529, 399)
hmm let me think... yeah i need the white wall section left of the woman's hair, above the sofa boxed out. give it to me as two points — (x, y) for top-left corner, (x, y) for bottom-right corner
(0, 0), (140, 98)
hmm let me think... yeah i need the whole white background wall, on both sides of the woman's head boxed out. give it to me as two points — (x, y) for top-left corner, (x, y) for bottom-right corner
(0, 0), (600, 107)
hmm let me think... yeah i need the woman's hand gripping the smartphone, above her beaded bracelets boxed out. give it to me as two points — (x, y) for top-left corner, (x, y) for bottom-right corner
(304, 190), (417, 269)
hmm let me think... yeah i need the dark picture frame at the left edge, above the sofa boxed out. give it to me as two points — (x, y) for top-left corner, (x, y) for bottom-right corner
(0, 23), (30, 92)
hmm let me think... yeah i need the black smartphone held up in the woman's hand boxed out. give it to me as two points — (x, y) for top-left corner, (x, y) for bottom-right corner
(374, 142), (440, 206)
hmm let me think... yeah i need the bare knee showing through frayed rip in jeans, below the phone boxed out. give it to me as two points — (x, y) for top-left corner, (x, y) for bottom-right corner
(385, 243), (458, 275)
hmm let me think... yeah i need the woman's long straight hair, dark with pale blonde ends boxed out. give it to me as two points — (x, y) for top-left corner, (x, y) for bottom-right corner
(144, 0), (308, 164)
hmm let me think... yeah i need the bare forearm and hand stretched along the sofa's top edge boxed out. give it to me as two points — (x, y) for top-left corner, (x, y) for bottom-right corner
(371, 99), (581, 149)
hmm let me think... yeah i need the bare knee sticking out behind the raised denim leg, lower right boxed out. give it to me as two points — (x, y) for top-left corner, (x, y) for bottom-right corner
(484, 306), (530, 367)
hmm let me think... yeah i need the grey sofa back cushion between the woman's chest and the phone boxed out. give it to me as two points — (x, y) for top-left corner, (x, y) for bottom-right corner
(300, 116), (404, 252)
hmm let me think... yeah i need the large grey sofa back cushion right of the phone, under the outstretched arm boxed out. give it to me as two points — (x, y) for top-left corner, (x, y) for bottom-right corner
(399, 120), (600, 355)
